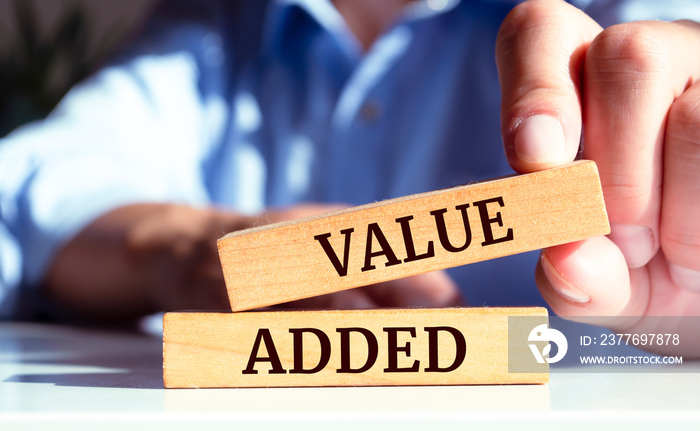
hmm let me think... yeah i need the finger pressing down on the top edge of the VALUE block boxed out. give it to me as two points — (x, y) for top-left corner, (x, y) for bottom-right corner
(496, 0), (602, 172)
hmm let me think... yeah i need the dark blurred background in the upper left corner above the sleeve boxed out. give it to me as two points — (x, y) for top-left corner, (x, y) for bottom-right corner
(0, 0), (158, 138)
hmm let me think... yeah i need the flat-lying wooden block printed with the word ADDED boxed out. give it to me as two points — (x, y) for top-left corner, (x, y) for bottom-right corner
(163, 307), (549, 388)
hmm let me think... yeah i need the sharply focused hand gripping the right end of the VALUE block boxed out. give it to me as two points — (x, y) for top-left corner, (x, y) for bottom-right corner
(497, 0), (700, 356)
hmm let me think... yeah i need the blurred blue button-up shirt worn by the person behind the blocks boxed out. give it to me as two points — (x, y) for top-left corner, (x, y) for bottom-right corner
(0, 0), (700, 318)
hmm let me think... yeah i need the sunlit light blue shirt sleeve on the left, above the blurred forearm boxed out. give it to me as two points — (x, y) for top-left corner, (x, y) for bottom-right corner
(0, 11), (231, 319)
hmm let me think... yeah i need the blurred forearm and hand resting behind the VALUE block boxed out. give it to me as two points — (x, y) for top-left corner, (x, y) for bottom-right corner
(45, 204), (459, 320)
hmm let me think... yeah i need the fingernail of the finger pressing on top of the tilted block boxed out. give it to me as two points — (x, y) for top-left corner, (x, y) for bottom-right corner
(513, 115), (566, 163)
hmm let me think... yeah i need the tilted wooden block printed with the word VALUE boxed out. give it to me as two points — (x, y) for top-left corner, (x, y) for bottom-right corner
(218, 161), (610, 311)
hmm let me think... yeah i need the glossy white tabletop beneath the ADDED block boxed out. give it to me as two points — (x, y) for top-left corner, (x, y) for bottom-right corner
(0, 323), (700, 430)
